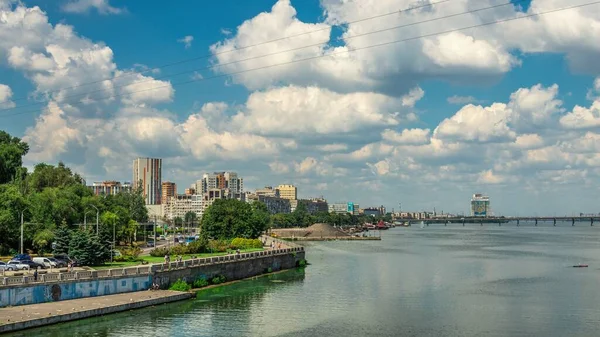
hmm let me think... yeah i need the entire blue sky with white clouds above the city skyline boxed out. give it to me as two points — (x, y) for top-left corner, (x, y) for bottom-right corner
(0, 0), (600, 216)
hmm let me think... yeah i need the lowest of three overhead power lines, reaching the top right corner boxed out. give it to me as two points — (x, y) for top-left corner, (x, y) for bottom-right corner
(0, 1), (600, 118)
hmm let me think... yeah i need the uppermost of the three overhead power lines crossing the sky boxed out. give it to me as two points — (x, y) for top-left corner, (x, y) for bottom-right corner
(0, 0), (454, 104)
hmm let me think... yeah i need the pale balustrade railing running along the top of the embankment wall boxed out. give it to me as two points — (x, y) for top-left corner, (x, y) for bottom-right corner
(0, 244), (304, 288)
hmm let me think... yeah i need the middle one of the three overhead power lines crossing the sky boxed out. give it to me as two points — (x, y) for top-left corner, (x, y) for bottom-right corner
(0, 0), (527, 112)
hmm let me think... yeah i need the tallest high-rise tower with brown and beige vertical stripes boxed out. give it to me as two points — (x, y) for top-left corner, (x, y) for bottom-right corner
(132, 158), (162, 205)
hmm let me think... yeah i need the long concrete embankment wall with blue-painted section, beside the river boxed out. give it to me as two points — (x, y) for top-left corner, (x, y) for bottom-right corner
(0, 243), (304, 308)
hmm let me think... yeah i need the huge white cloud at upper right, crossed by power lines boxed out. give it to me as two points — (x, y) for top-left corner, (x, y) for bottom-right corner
(211, 0), (600, 93)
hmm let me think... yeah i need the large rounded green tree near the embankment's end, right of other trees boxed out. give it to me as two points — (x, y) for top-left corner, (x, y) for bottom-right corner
(200, 199), (269, 239)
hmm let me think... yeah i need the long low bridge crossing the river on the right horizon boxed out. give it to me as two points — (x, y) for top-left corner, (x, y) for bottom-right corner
(394, 215), (600, 226)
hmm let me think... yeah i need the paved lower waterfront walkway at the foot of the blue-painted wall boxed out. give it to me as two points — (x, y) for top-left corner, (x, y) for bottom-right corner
(0, 290), (193, 334)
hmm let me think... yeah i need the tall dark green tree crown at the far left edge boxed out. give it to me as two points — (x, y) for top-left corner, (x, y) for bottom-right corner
(0, 130), (29, 184)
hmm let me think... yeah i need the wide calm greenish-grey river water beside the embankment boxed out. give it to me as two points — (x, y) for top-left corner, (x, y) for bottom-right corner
(8, 223), (600, 337)
